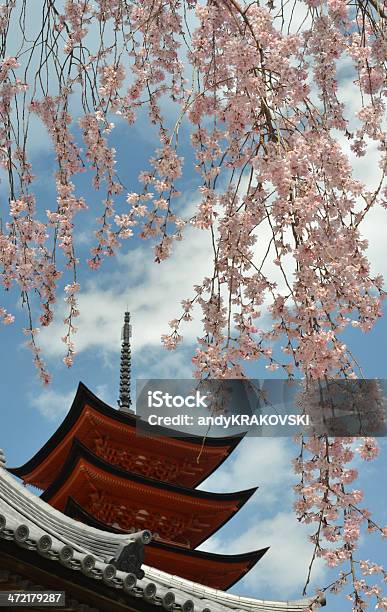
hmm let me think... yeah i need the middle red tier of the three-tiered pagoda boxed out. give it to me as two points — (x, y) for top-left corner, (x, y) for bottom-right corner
(41, 439), (257, 549)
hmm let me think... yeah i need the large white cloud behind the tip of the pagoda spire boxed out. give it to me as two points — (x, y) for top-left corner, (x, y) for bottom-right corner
(39, 228), (212, 362)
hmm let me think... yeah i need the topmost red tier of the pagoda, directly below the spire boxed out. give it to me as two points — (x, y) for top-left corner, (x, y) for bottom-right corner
(9, 383), (243, 490)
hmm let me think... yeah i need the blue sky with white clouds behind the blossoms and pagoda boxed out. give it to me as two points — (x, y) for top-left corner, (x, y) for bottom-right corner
(0, 3), (387, 612)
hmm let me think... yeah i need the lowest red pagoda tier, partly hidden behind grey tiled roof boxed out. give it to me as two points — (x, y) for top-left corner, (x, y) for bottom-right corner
(65, 497), (269, 590)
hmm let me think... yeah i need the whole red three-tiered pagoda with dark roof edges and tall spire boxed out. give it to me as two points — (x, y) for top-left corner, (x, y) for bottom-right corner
(8, 312), (268, 590)
